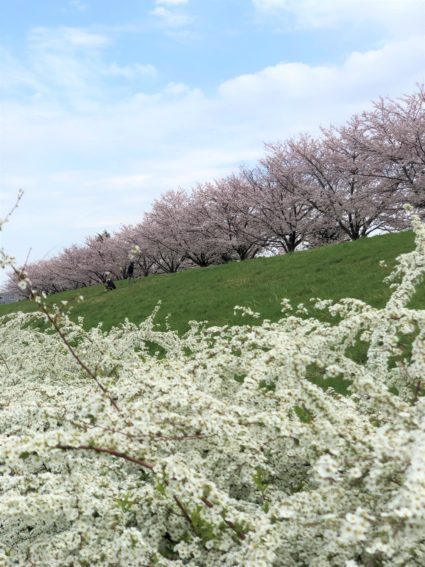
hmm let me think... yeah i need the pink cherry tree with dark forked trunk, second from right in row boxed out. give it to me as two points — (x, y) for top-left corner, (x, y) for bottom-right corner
(289, 125), (402, 240)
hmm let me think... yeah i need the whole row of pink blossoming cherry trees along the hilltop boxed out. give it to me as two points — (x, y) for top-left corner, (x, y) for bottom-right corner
(8, 86), (425, 293)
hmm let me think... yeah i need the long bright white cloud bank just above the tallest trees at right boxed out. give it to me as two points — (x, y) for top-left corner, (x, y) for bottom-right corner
(220, 36), (424, 108)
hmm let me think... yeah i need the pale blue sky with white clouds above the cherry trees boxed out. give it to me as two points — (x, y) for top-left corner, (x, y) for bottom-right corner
(0, 0), (425, 285)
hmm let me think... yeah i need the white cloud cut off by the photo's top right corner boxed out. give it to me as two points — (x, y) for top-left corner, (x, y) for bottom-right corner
(252, 0), (425, 35)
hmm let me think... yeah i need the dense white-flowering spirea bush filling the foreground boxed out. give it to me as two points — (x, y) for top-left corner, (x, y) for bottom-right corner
(0, 220), (425, 567)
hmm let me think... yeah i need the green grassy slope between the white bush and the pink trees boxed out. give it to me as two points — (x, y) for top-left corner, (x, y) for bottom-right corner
(0, 232), (425, 332)
